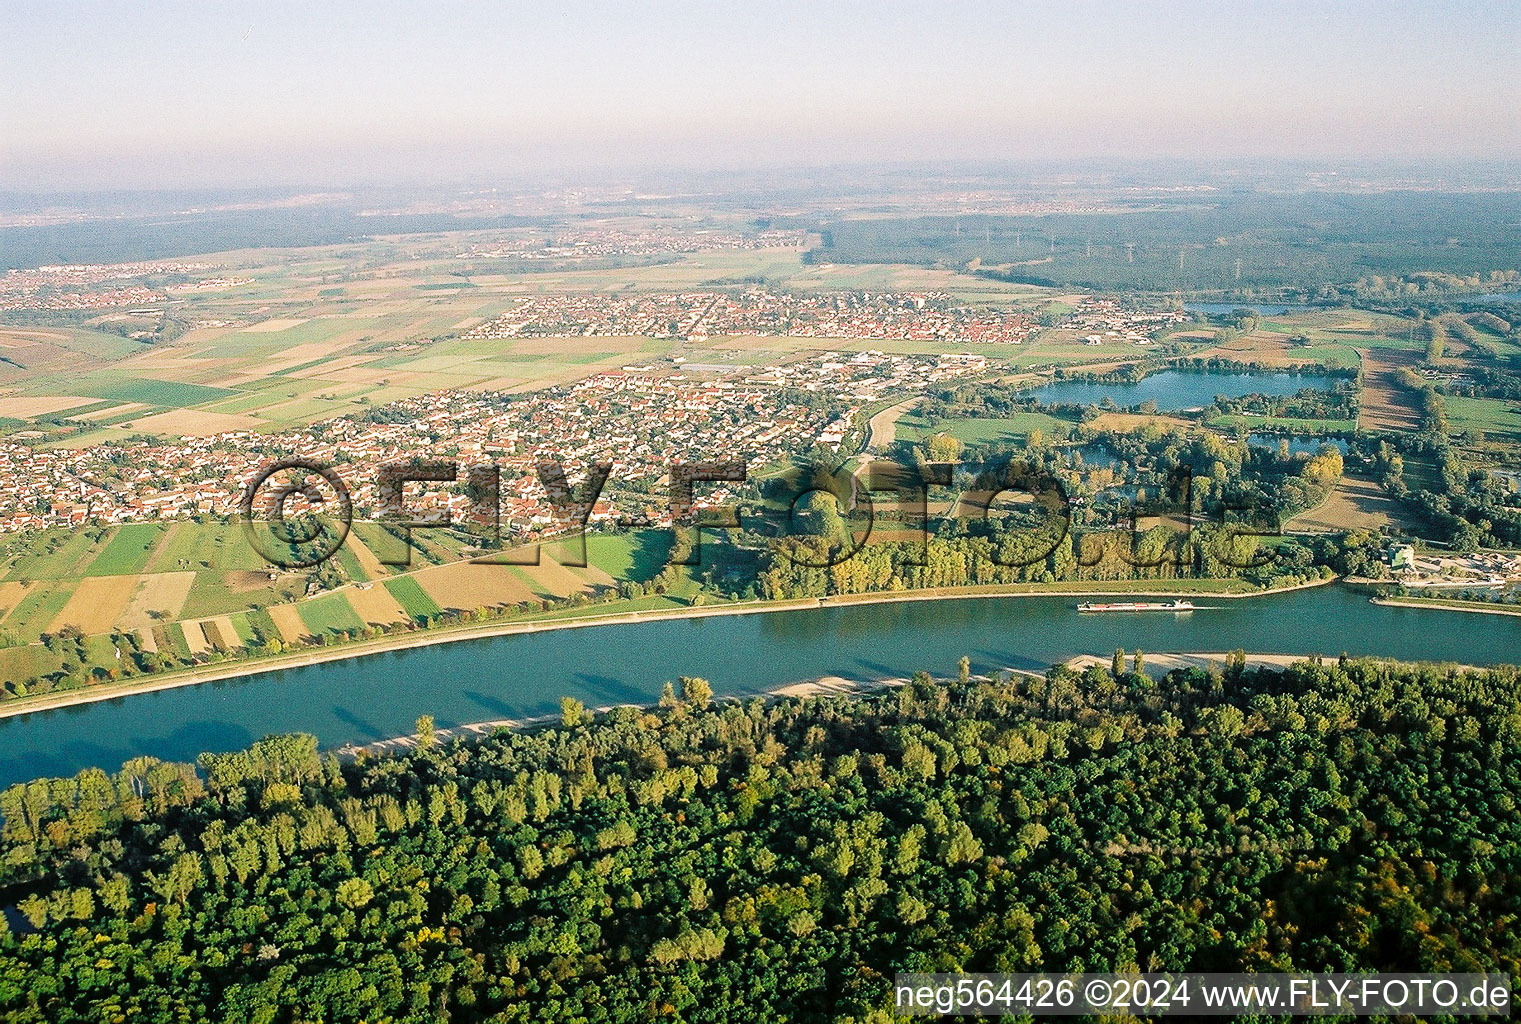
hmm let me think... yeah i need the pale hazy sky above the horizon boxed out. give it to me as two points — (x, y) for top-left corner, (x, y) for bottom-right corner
(0, 0), (1521, 189)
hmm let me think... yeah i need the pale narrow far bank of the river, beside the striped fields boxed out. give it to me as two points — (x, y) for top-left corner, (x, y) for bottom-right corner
(0, 577), (1335, 720)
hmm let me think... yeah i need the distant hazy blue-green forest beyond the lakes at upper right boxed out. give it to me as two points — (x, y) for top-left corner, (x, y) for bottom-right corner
(809, 192), (1521, 298)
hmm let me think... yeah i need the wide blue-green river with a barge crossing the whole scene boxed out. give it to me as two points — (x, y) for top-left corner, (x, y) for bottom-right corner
(0, 586), (1521, 785)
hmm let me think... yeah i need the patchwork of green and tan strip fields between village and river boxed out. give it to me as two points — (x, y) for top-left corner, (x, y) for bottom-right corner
(0, 520), (684, 683)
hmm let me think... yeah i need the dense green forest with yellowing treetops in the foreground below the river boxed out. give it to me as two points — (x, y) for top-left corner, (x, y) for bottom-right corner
(0, 653), (1521, 1024)
